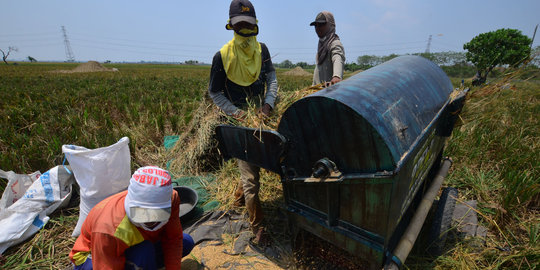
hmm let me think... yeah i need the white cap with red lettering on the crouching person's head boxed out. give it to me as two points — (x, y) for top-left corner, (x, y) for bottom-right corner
(124, 166), (173, 223)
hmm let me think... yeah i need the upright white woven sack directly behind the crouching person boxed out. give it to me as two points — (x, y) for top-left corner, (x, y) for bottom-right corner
(62, 137), (131, 237)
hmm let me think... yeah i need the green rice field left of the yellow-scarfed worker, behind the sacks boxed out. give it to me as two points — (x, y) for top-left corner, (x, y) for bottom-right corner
(0, 64), (209, 172)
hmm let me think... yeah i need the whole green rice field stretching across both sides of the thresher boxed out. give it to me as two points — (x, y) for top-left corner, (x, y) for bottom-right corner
(0, 63), (540, 269)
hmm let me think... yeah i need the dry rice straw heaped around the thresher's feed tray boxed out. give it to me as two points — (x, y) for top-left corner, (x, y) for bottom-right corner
(168, 85), (323, 212)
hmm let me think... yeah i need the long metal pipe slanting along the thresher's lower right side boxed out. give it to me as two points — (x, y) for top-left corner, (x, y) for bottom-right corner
(384, 158), (452, 269)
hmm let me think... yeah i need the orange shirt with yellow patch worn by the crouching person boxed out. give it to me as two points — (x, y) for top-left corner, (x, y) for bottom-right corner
(69, 190), (183, 269)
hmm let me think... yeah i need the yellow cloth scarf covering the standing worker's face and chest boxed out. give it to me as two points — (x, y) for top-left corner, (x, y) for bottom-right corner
(219, 33), (262, 86)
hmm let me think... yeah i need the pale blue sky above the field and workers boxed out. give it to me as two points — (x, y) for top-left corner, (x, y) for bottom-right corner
(0, 0), (540, 64)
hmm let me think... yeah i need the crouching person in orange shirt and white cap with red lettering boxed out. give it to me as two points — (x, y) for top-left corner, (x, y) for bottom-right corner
(69, 166), (194, 269)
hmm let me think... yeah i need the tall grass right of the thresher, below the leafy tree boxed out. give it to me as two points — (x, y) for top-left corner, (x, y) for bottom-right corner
(435, 76), (540, 269)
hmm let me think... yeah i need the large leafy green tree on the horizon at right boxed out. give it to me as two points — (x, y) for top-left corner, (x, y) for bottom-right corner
(463, 28), (532, 85)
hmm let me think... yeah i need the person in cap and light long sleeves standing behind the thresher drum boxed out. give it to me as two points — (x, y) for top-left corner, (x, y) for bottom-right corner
(309, 11), (345, 86)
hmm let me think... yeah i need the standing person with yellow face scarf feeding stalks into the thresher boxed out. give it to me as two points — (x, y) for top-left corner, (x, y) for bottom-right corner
(208, 0), (278, 247)
